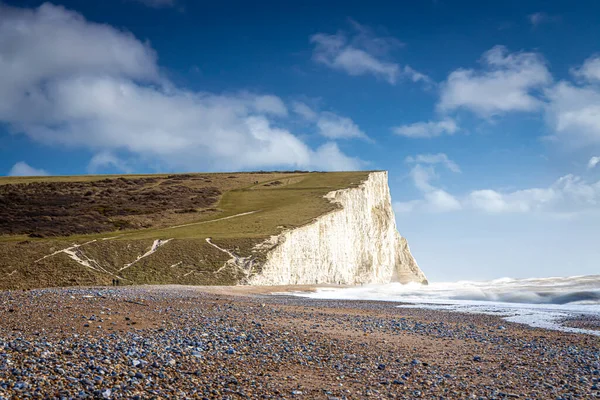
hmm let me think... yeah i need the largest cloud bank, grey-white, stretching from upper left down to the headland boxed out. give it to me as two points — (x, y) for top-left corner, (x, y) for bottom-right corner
(0, 4), (360, 170)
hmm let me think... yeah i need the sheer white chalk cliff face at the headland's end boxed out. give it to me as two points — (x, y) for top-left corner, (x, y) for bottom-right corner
(247, 171), (427, 285)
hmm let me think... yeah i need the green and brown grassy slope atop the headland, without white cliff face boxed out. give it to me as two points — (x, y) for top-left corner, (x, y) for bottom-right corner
(0, 172), (368, 289)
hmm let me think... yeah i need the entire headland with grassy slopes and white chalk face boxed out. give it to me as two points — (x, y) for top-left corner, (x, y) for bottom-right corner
(0, 171), (426, 289)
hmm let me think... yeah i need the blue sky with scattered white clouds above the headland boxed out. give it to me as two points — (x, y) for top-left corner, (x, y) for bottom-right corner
(0, 0), (600, 281)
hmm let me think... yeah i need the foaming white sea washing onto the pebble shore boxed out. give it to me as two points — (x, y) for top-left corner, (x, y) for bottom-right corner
(288, 275), (600, 336)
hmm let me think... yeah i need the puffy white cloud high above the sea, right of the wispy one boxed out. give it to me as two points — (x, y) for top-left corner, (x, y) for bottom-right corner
(438, 46), (552, 117)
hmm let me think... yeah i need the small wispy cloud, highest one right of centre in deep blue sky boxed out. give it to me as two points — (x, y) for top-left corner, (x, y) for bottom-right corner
(310, 21), (430, 85)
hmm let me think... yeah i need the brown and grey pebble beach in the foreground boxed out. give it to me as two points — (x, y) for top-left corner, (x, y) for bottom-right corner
(0, 286), (600, 400)
